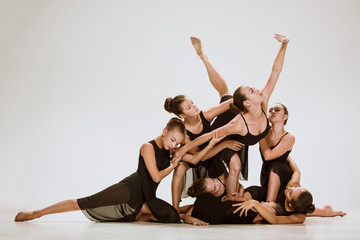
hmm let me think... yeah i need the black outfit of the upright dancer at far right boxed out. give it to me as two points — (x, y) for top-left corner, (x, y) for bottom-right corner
(260, 132), (293, 190)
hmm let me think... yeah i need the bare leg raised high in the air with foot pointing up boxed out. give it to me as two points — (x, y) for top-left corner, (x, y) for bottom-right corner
(191, 37), (229, 99)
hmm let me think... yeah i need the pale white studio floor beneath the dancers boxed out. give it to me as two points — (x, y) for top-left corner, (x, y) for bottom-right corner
(0, 210), (360, 240)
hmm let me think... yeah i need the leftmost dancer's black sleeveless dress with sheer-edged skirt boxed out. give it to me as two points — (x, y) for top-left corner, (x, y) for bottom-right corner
(77, 140), (180, 223)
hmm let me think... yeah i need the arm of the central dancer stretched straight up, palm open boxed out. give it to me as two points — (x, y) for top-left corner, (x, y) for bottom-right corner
(261, 34), (289, 109)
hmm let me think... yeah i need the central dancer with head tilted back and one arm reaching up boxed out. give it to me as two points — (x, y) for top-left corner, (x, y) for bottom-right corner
(178, 34), (289, 195)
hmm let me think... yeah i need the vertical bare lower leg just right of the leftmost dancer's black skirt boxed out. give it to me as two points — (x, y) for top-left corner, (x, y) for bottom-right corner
(171, 163), (188, 211)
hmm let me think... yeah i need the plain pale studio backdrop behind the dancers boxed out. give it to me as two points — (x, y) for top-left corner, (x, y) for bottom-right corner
(0, 0), (360, 218)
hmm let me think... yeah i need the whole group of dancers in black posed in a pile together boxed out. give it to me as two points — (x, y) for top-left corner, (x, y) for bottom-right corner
(15, 34), (346, 226)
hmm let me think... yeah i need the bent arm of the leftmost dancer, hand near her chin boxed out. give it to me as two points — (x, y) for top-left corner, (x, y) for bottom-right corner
(140, 143), (180, 183)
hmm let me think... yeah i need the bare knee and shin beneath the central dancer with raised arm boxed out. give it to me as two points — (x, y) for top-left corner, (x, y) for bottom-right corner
(225, 154), (241, 195)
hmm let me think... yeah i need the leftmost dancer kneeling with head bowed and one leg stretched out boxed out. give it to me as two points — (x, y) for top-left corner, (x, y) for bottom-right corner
(15, 118), (186, 223)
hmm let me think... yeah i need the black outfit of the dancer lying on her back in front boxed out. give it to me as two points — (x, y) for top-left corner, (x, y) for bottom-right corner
(191, 193), (257, 224)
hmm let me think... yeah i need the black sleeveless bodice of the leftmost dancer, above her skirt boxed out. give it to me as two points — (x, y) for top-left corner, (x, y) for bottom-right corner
(137, 140), (170, 198)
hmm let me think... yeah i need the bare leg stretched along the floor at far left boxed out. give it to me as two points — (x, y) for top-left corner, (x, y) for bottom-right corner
(14, 199), (80, 222)
